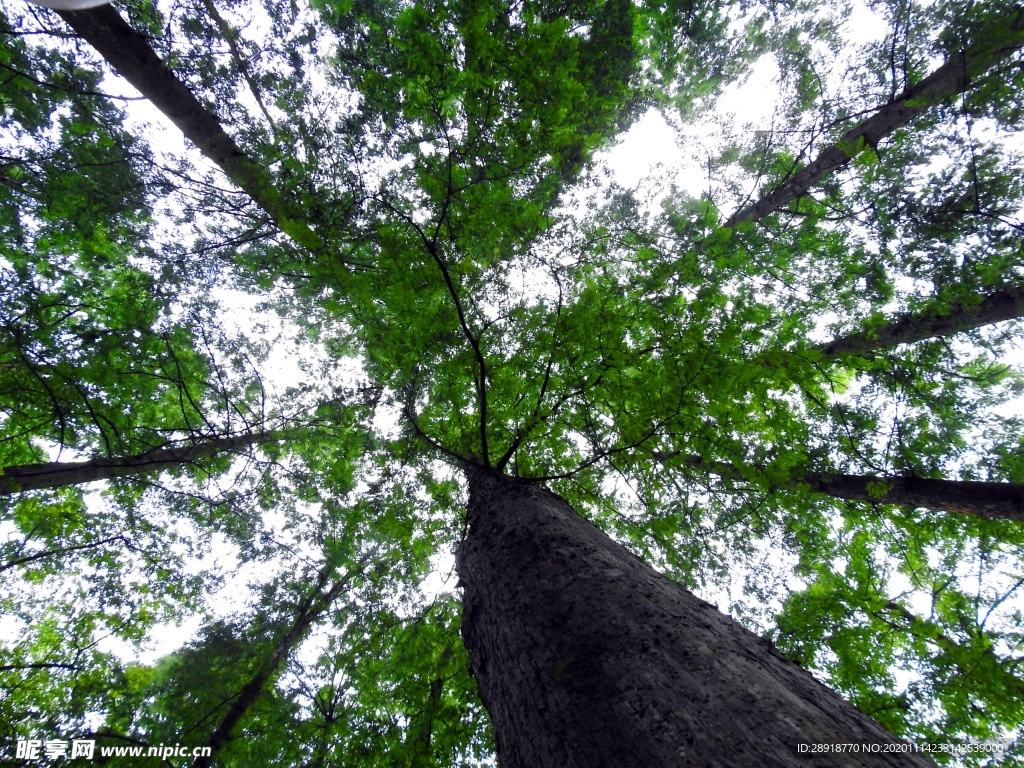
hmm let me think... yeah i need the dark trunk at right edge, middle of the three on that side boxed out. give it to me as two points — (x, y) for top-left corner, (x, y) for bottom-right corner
(814, 286), (1024, 358)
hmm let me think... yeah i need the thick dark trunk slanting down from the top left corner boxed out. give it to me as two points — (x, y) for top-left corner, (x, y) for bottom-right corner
(57, 5), (325, 253)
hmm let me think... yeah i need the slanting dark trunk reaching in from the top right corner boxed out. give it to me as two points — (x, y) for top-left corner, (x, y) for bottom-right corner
(723, 7), (1024, 227)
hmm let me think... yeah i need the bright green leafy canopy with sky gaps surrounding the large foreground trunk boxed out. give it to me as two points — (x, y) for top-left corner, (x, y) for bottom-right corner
(0, 0), (1024, 766)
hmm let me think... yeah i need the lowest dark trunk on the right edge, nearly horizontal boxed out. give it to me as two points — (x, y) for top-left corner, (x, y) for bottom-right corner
(679, 455), (1024, 520)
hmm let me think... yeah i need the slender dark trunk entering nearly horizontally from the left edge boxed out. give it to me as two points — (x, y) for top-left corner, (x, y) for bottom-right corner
(0, 432), (284, 496)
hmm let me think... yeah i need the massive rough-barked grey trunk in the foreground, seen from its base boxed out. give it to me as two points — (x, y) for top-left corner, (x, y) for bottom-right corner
(458, 468), (932, 768)
